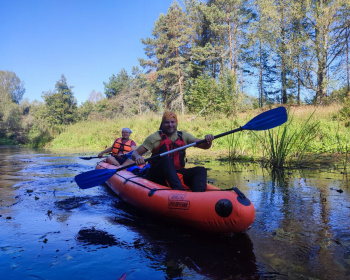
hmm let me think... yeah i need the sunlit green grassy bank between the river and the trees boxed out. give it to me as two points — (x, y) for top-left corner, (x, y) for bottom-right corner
(48, 105), (350, 165)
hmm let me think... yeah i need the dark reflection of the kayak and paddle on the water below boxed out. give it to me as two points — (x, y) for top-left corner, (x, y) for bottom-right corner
(76, 204), (258, 279)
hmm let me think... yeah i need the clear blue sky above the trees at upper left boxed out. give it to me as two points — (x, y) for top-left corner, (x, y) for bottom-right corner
(0, 0), (173, 104)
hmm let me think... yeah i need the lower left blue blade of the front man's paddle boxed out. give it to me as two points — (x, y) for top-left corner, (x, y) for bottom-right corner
(74, 169), (115, 189)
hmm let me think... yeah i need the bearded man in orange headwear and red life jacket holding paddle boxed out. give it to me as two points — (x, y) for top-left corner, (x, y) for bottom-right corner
(131, 111), (214, 192)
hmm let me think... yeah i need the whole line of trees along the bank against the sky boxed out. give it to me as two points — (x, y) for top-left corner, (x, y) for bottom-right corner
(0, 0), (350, 146)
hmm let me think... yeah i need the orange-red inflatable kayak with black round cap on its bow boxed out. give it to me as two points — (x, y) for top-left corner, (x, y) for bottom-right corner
(96, 162), (255, 233)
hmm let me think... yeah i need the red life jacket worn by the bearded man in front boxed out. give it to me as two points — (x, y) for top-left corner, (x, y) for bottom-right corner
(151, 130), (186, 170)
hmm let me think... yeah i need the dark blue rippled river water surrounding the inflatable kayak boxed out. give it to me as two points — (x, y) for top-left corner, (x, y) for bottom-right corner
(0, 147), (350, 280)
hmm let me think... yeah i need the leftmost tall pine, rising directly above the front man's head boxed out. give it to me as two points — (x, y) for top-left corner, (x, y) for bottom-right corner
(140, 1), (191, 114)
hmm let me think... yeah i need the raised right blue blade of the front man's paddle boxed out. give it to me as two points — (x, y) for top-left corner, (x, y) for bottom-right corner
(242, 106), (288, 130)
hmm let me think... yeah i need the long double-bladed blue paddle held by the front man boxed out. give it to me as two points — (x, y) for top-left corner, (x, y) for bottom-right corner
(75, 107), (288, 189)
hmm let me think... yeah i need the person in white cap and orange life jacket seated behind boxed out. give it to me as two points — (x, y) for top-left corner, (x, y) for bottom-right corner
(98, 127), (136, 166)
